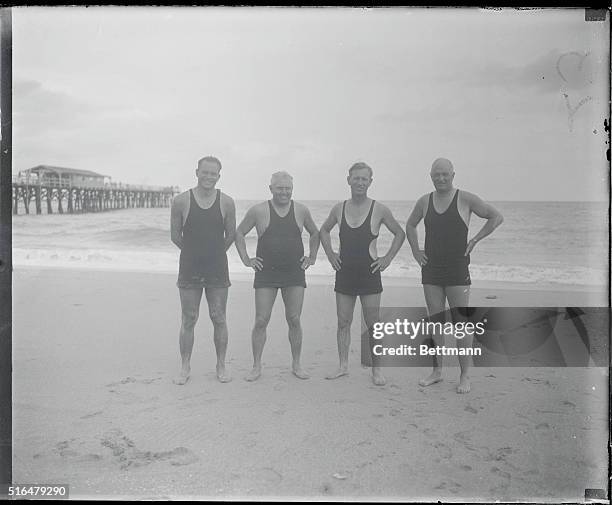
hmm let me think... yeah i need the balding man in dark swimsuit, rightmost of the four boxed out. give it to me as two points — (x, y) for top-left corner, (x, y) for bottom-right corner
(406, 158), (504, 393)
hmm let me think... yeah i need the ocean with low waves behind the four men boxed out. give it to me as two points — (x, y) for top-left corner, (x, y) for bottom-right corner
(13, 200), (609, 286)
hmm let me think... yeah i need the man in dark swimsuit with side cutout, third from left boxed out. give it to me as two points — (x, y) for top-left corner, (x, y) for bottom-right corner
(320, 162), (405, 386)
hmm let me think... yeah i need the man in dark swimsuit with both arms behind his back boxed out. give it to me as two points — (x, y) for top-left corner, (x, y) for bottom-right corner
(170, 156), (236, 384)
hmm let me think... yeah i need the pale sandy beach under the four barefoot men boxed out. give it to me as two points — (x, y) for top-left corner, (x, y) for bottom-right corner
(13, 268), (608, 502)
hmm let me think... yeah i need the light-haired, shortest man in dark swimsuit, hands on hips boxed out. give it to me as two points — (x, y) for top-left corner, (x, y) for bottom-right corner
(236, 172), (319, 381)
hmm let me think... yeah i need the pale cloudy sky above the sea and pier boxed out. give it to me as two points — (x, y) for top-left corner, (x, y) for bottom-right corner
(7, 7), (609, 201)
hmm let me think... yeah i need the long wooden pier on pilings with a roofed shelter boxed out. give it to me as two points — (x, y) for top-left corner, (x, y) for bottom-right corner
(13, 177), (178, 215)
